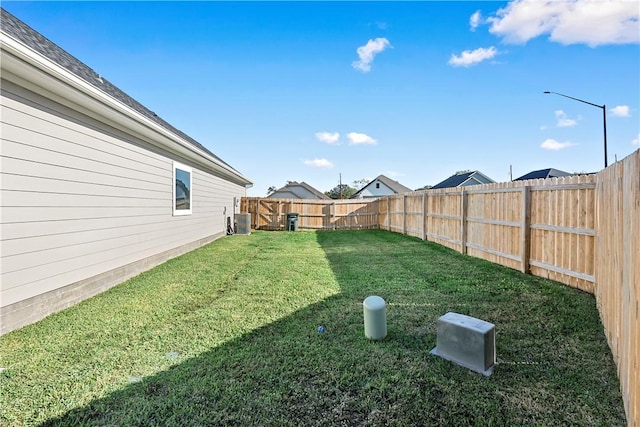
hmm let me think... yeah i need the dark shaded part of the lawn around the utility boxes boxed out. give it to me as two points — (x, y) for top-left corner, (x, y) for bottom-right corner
(43, 231), (626, 426)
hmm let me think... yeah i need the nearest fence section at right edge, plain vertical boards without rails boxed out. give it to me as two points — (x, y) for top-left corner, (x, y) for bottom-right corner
(595, 150), (640, 426)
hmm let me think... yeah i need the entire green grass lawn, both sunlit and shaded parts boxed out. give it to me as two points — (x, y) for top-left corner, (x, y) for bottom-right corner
(0, 230), (626, 427)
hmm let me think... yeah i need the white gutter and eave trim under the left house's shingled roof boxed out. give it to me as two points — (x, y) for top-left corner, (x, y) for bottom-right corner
(0, 32), (252, 188)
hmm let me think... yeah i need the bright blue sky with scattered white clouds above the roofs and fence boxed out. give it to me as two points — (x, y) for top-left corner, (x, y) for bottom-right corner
(2, 0), (640, 196)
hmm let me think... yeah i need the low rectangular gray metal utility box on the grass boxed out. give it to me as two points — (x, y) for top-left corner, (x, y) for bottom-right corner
(431, 312), (496, 376)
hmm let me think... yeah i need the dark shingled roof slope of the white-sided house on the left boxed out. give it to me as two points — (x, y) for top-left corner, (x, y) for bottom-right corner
(0, 8), (251, 185)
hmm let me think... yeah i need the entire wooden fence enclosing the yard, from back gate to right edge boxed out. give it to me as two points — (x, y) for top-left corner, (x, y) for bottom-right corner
(241, 150), (640, 427)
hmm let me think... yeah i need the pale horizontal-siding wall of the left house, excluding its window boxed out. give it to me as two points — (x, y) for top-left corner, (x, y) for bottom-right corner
(0, 79), (246, 333)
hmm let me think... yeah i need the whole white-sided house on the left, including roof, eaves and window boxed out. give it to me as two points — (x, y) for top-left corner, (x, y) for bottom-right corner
(0, 9), (251, 333)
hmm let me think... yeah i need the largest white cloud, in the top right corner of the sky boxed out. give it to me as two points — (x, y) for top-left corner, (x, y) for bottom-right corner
(486, 0), (640, 47)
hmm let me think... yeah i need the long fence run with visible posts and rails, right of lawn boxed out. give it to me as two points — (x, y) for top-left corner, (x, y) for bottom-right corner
(378, 175), (596, 293)
